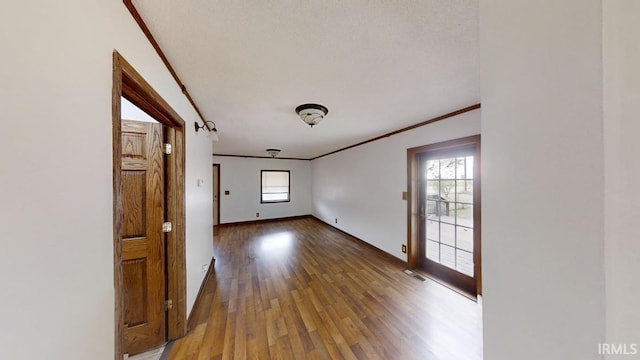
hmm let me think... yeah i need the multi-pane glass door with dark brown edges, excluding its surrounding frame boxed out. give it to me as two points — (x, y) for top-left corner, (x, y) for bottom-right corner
(418, 144), (480, 296)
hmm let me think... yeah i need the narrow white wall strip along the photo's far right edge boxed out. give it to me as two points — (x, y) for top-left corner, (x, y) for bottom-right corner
(603, 0), (640, 359)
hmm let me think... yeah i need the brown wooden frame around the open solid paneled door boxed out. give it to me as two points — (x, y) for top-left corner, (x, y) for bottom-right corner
(112, 50), (187, 360)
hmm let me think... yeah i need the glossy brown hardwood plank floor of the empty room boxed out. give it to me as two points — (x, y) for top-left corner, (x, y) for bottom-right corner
(169, 218), (482, 360)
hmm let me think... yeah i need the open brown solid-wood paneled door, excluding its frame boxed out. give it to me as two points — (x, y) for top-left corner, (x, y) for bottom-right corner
(122, 120), (166, 355)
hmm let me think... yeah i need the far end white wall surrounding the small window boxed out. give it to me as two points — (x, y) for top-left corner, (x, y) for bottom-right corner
(210, 156), (311, 224)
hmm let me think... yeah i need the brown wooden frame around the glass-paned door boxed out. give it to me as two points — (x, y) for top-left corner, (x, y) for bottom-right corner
(407, 135), (482, 296)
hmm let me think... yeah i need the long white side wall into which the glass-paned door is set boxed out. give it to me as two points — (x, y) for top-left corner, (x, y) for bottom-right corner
(311, 110), (480, 261)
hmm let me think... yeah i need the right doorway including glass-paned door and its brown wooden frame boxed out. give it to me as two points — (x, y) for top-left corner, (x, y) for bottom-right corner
(407, 135), (482, 298)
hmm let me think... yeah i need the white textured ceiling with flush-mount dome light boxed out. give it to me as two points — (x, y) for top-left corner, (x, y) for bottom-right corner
(134, 0), (480, 158)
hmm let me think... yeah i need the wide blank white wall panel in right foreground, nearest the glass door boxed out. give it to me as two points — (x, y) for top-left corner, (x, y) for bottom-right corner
(480, 0), (605, 360)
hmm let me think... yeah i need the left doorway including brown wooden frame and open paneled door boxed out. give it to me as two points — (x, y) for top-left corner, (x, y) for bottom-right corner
(112, 51), (186, 359)
